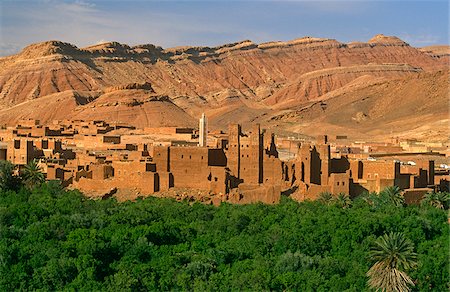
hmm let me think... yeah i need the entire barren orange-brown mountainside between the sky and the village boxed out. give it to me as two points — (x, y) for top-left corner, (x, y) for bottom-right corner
(0, 35), (448, 138)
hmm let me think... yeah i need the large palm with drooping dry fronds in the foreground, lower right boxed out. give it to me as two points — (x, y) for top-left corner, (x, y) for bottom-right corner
(367, 232), (417, 292)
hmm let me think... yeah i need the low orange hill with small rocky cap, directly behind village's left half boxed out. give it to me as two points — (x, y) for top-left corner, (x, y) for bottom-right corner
(0, 86), (197, 128)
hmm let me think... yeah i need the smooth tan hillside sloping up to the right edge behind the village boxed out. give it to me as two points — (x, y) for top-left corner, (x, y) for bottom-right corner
(271, 71), (450, 141)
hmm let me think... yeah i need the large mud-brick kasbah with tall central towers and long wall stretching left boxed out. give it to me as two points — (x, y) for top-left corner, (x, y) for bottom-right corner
(75, 125), (283, 203)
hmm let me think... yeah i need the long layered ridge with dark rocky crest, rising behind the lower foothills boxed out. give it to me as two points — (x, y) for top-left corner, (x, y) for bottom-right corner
(0, 35), (448, 139)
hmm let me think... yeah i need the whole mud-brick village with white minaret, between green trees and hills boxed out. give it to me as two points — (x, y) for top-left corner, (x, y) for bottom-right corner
(0, 114), (450, 205)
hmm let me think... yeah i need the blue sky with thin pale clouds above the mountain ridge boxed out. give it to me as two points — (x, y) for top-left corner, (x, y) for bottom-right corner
(0, 0), (449, 56)
